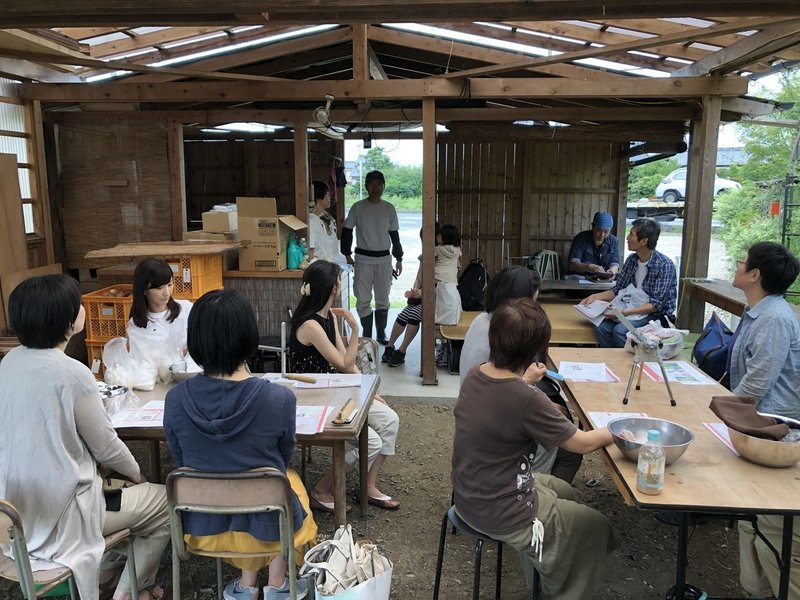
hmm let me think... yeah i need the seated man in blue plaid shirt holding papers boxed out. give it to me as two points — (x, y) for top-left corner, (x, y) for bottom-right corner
(581, 219), (678, 348)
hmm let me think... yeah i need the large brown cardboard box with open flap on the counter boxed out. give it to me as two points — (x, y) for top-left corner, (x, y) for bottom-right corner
(236, 197), (307, 271)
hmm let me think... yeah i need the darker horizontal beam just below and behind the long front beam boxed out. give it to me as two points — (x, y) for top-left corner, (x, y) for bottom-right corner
(46, 105), (700, 127)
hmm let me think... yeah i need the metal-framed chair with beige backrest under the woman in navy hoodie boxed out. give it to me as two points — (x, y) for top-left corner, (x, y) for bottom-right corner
(167, 467), (297, 600)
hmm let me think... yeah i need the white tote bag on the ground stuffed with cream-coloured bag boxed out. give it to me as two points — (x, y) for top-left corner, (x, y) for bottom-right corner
(300, 525), (392, 600)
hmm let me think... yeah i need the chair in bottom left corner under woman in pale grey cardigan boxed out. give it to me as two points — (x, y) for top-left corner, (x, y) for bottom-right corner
(0, 500), (139, 600)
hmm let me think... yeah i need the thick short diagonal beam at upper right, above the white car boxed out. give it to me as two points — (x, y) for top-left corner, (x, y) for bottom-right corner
(672, 21), (800, 77)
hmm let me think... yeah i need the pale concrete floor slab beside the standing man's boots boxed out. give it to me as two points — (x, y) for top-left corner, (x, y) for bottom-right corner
(368, 308), (459, 404)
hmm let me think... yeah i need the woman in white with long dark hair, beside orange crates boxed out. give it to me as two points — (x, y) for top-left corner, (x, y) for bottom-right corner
(128, 258), (192, 373)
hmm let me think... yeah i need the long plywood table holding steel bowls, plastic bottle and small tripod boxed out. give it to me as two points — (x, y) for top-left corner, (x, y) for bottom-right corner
(548, 348), (800, 599)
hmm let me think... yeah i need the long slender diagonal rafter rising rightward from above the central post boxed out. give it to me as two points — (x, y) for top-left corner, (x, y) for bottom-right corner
(441, 19), (800, 78)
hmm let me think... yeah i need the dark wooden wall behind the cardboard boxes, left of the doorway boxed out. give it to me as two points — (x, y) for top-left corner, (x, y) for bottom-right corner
(184, 137), (342, 223)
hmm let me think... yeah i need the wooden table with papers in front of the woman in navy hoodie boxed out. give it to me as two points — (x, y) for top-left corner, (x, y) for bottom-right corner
(117, 375), (380, 527)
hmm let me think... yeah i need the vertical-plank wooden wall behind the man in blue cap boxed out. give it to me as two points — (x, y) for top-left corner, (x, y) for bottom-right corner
(437, 140), (625, 273)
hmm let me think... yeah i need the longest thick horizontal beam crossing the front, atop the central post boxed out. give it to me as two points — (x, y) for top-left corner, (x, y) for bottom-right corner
(20, 77), (748, 102)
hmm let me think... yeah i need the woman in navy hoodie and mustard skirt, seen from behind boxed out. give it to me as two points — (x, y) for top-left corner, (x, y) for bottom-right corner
(164, 290), (317, 600)
